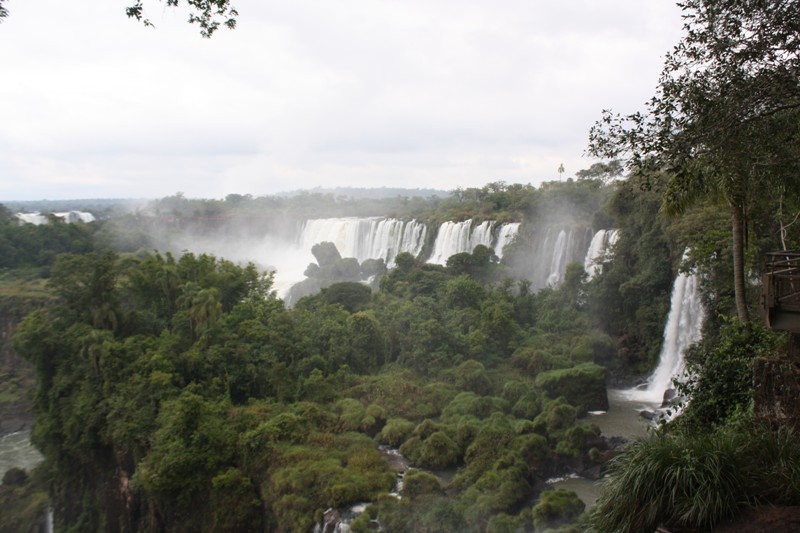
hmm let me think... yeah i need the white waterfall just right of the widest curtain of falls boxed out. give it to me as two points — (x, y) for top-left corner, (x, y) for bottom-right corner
(428, 219), (519, 265)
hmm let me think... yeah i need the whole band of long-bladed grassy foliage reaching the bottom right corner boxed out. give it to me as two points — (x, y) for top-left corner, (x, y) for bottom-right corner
(591, 423), (800, 532)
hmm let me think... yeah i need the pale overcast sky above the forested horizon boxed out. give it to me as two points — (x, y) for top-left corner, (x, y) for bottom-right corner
(0, 0), (682, 201)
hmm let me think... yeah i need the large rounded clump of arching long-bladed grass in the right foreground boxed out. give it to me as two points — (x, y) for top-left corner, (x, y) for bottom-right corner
(591, 430), (756, 532)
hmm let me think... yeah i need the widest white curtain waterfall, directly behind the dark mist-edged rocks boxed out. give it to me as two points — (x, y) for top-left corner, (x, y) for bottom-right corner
(300, 218), (427, 264)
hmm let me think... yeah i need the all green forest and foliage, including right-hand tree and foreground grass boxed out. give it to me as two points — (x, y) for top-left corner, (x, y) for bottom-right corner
(6, 0), (800, 533)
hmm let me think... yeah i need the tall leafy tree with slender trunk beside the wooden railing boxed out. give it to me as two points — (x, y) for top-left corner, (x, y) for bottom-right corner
(589, 0), (800, 324)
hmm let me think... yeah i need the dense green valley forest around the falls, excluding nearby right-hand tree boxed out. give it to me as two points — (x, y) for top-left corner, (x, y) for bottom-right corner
(0, 156), (800, 531)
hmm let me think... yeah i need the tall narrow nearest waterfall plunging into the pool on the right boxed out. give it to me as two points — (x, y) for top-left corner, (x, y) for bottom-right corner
(626, 255), (705, 404)
